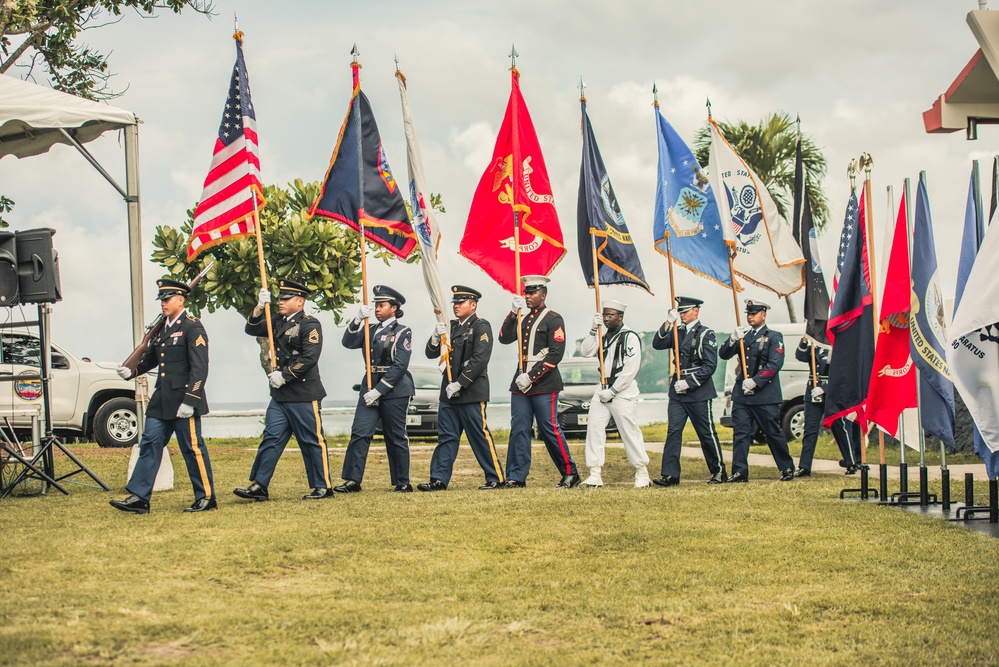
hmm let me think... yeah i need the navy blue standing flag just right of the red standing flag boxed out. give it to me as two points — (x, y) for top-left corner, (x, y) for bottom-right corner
(909, 174), (954, 451)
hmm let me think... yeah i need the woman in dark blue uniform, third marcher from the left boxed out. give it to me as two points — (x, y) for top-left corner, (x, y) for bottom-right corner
(334, 285), (416, 493)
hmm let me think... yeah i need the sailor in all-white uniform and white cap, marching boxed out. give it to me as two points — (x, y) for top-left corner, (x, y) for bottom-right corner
(579, 299), (651, 489)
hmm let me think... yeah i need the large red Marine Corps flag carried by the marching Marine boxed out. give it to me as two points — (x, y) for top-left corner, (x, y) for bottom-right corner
(458, 67), (566, 294)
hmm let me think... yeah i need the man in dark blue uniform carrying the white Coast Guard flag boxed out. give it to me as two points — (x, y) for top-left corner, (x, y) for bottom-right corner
(718, 299), (794, 483)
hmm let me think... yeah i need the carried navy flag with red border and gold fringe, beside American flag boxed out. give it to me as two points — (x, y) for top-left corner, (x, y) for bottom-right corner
(308, 67), (416, 259)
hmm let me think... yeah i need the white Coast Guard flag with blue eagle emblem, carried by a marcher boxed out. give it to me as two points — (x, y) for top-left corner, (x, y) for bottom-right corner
(709, 120), (805, 296)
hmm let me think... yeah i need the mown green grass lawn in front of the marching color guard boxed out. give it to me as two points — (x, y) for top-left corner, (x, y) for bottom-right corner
(0, 439), (999, 665)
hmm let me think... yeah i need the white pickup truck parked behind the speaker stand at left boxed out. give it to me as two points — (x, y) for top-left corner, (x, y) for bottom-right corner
(0, 330), (139, 447)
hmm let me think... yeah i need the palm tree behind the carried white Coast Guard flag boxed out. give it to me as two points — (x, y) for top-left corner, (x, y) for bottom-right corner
(694, 113), (829, 322)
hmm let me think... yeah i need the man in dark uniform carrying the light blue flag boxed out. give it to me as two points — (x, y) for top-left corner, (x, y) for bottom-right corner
(652, 296), (727, 486)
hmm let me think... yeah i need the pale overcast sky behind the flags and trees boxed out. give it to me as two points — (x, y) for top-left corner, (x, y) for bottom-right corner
(0, 0), (999, 404)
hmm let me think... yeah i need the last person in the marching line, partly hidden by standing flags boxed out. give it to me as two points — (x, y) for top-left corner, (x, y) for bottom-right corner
(794, 336), (862, 477)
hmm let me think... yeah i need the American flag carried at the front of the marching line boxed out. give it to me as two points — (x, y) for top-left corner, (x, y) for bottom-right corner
(187, 32), (264, 262)
